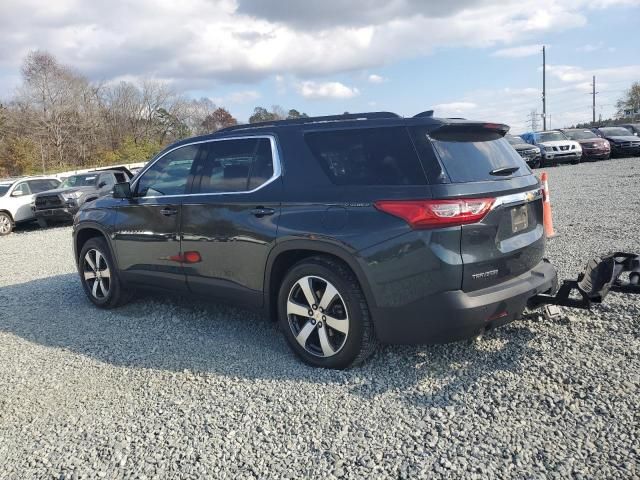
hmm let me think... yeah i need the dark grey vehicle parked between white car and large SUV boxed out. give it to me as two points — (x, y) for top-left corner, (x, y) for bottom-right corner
(31, 167), (132, 224)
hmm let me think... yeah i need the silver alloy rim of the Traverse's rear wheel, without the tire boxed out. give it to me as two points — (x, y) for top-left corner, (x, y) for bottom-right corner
(287, 276), (349, 358)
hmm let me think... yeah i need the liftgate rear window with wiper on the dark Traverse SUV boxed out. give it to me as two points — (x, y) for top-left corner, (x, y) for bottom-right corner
(414, 127), (531, 183)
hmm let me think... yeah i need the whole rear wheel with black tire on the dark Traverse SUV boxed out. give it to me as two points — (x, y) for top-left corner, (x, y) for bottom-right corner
(278, 256), (377, 369)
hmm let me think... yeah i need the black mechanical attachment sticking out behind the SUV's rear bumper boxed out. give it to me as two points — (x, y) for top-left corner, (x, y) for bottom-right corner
(528, 252), (640, 318)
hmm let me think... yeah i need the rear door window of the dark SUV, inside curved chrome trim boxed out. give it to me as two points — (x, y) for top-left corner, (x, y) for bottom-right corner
(196, 138), (274, 193)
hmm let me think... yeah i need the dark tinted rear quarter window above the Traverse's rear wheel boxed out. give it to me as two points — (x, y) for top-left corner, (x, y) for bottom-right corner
(305, 127), (426, 185)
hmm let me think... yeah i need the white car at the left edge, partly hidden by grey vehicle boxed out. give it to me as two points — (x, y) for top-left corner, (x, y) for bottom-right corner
(0, 177), (60, 236)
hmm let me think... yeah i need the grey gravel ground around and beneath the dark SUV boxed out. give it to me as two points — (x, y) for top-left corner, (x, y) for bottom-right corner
(0, 158), (640, 479)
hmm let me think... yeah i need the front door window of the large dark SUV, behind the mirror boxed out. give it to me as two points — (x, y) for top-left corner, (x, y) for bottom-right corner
(136, 145), (200, 197)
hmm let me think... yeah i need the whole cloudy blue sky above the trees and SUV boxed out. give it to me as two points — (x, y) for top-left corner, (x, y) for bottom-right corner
(0, 0), (640, 133)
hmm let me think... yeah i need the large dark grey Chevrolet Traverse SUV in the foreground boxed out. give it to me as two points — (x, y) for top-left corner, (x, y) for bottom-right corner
(73, 112), (556, 368)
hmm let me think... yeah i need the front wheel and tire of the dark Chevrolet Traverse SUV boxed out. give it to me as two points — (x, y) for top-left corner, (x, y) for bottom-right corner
(78, 238), (131, 308)
